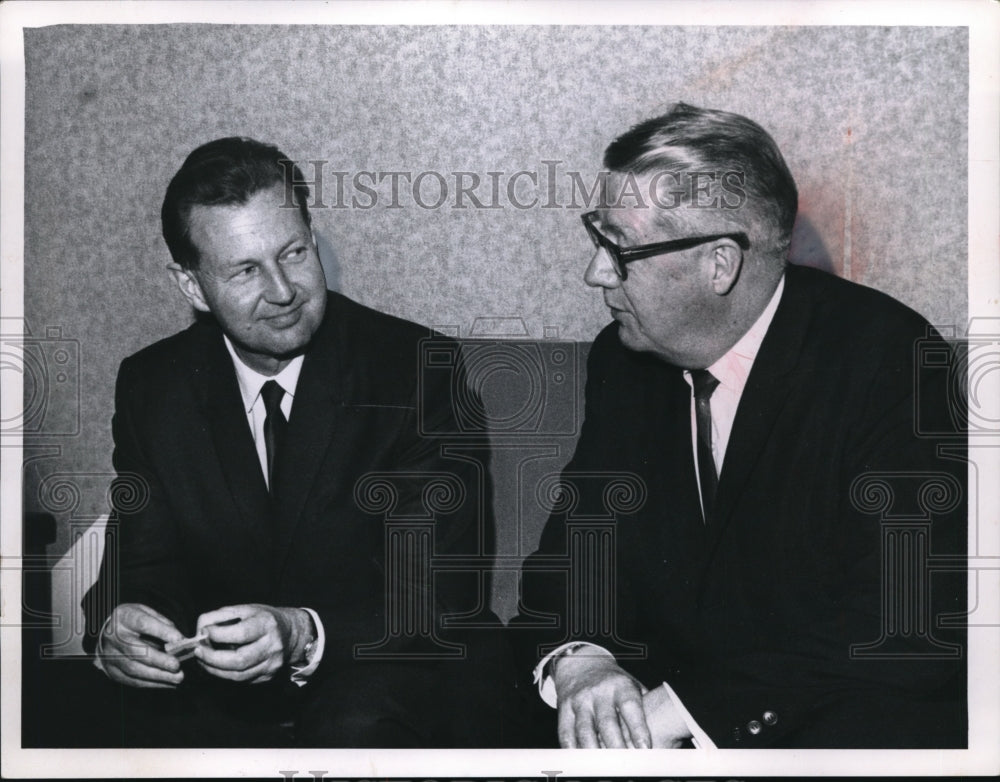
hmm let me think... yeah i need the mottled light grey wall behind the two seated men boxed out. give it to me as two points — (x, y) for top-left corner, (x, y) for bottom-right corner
(24, 20), (968, 620)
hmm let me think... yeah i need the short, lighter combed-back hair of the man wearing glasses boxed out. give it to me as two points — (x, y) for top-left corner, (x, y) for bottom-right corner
(604, 103), (798, 255)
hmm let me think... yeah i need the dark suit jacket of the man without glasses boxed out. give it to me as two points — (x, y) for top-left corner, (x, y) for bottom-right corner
(85, 293), (494, 678)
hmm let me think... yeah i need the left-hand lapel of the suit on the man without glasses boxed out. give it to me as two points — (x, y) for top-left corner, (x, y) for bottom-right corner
(195, 326), (271, 551)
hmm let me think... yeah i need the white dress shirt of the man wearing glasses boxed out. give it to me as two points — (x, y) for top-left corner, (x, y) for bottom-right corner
(534, 276), (785, 749)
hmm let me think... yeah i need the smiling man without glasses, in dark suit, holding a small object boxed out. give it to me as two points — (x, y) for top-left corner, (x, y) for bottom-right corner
(85, 138), (503, 746)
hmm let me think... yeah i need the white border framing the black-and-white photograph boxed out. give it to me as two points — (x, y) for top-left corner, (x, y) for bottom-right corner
(0, 0), (1000, 779)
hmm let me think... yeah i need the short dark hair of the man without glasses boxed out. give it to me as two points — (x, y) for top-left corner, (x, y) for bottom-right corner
(160, 136), (311, 269)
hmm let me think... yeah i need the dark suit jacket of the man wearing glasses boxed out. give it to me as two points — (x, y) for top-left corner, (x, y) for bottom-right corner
(522, 267), (967, 747)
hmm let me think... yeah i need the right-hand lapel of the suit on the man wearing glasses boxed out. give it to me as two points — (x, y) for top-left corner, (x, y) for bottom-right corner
(711, 267), (811, 536)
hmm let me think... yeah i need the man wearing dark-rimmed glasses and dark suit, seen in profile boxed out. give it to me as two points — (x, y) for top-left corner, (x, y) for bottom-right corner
(522, 104), (967, 748)
